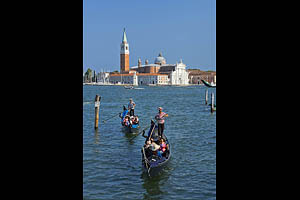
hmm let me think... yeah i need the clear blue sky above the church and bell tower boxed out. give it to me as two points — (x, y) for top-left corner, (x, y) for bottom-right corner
(83, 0), (216, 72)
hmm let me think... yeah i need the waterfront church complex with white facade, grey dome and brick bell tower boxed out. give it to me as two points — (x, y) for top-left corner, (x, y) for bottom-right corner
(109, 29), (189, 85)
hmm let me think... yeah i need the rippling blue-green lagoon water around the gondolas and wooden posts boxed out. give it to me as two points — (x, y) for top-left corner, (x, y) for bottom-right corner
(83, 86), (216, 200)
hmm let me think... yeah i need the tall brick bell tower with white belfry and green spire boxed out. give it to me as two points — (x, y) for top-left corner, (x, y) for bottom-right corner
(120, 28), (129, 73)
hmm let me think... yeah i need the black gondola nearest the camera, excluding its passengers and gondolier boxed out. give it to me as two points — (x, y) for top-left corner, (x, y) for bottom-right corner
(141, 126), (171, 177)
